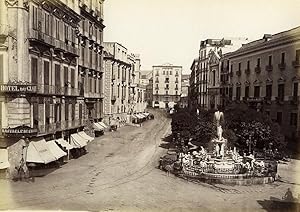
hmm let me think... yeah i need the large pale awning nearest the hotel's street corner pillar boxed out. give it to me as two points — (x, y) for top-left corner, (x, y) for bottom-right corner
(26, 138), (56, 164)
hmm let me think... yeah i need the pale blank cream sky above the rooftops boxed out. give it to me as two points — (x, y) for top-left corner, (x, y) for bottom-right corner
(104, 0), (300, 73)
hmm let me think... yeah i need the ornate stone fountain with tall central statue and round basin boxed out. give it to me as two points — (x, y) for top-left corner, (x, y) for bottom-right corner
(162, 110), (277, 185)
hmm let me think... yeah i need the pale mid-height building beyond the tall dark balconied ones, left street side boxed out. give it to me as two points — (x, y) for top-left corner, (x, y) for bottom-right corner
(104, 42), (145, 124)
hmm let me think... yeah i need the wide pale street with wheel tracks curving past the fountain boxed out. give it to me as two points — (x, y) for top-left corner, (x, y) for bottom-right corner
(0, 111), (300, 211)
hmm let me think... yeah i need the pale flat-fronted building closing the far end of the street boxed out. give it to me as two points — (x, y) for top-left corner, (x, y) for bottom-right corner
(152, 64), (182, 108)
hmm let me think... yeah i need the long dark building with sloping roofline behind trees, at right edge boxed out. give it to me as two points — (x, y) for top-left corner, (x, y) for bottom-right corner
(223, 27), (300, 138)
